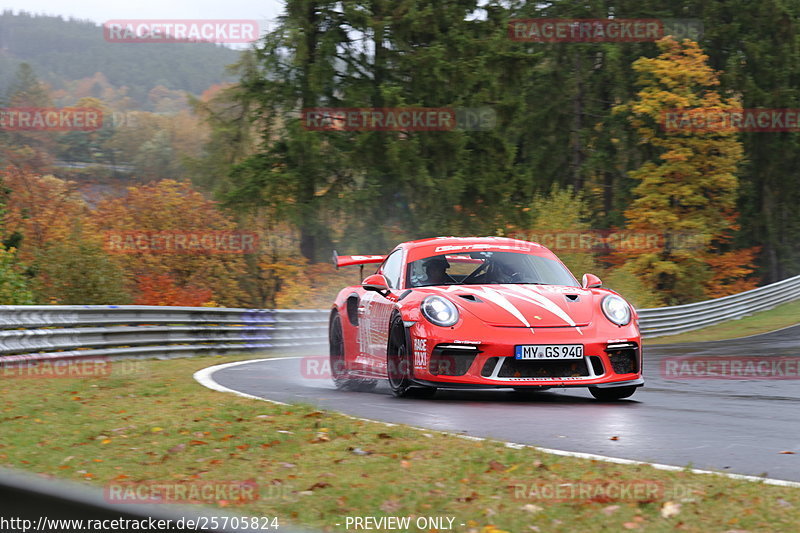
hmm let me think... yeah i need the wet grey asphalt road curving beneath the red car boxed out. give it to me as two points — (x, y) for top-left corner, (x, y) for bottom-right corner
(212, 325), (800, 481)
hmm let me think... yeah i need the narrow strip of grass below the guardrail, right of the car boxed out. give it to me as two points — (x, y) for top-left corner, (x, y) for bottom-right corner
(645, 300), (800, 345)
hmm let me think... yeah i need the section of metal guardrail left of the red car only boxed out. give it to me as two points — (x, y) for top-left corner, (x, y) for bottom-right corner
(0, 305), (327, 364)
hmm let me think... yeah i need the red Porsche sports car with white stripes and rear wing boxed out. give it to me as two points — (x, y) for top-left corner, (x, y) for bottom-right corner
(329, 237), (644, 400)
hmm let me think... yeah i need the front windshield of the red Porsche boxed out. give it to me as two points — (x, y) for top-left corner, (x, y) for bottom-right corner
(407, 251), (577, 287)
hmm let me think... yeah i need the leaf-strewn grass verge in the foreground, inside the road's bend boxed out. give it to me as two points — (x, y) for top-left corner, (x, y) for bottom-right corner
(0, 357), (800, 533)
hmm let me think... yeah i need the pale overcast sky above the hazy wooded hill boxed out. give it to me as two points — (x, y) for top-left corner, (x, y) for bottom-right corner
(0, 0), (284, 24)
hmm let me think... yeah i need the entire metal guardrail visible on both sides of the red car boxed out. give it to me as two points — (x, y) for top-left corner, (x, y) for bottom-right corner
(0, 276), (800, 364)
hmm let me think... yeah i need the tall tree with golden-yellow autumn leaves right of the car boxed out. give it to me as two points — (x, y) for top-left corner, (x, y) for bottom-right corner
(619, 38), (754, 304)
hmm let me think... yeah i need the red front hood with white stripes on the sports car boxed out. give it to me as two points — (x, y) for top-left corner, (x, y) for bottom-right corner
(432, 284), (595, 328)
